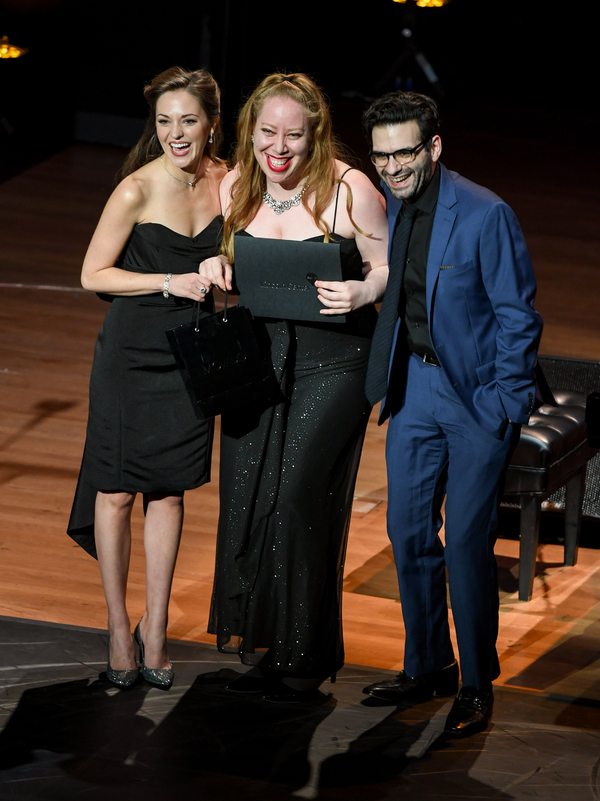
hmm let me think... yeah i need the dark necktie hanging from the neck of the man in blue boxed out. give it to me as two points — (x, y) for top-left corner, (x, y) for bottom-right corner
(365, 204), (417, 406)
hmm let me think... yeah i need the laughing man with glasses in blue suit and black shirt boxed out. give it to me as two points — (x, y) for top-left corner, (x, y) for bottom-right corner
(364, 92), (542, 736)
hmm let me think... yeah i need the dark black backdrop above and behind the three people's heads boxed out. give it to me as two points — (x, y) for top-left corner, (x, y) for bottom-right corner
(0, 0), (598, 176)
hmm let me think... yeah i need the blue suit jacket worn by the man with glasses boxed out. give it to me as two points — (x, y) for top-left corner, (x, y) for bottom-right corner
(382, 164), (543, 437)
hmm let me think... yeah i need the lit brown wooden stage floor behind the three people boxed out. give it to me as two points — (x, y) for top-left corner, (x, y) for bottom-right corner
(0, 139), (600, 701)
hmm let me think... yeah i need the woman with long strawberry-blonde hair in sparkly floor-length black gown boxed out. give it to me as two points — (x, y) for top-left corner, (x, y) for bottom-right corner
(201, 74), (388, 702)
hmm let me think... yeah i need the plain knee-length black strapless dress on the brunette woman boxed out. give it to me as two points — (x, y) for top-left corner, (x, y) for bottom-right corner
(68, 217), (222, 556)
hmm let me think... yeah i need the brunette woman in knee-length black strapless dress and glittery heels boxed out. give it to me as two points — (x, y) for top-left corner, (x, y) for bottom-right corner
(69, 67), (226, 686)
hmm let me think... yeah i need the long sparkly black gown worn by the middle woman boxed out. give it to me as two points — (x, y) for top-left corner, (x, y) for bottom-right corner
(208, 236), (377, 678)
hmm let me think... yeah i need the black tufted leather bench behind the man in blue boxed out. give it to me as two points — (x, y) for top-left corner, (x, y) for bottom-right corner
(503, 389), (596, 601)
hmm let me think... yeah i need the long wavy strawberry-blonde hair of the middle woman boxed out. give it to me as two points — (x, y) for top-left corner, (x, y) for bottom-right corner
(222, 72), (362, 263)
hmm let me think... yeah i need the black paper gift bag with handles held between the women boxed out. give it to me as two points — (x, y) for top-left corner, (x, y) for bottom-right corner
(166, 292), (280, 420)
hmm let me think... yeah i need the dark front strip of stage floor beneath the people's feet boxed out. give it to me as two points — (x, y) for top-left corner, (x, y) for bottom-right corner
(0, 618), (600, 801)
